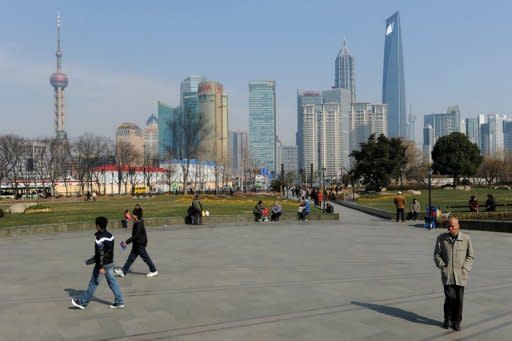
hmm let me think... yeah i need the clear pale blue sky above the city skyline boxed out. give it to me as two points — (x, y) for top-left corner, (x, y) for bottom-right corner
(0, 0), (512, 145)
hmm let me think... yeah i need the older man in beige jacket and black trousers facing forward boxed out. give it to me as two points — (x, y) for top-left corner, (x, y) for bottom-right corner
(434, 216), (475, 330)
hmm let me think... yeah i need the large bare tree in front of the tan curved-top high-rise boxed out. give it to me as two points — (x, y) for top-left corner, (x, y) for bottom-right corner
(165, 112), (214, 193)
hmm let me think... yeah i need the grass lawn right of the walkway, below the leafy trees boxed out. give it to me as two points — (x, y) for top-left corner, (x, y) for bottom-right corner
(357, 188), (512, 213)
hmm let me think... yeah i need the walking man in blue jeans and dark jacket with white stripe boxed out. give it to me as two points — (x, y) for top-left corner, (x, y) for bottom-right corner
(71, 217), (124, 309)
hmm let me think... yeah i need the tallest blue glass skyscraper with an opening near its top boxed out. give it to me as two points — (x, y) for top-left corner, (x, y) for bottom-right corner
(382, 12), (407, 138)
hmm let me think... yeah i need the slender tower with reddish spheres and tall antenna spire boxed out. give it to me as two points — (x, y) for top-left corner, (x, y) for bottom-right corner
(50, 10), (68, 140)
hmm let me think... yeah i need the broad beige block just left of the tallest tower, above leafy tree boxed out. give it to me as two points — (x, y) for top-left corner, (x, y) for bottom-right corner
(350, 102), (388, 151)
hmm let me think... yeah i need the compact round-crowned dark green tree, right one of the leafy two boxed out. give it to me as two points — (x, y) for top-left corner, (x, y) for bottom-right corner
(432, 133), (483, 185)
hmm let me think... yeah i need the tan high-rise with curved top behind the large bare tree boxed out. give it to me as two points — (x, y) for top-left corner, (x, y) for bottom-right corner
(198, 81), (229, 164)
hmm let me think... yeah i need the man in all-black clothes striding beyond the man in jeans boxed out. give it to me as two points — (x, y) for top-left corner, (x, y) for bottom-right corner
(115, 209), (158, 277)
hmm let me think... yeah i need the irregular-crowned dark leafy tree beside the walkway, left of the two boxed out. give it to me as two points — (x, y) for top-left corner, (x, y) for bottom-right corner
(350, 134), (407, 192)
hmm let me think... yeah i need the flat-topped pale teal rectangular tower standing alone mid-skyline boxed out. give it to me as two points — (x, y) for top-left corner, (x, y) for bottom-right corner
(248, 81), (276, 171)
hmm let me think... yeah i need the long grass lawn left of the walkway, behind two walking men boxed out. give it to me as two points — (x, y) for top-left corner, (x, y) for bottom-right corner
(0, 194), (297, 227)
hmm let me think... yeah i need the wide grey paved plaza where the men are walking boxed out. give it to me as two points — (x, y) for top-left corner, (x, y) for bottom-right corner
(0, 207), (512, 341)
